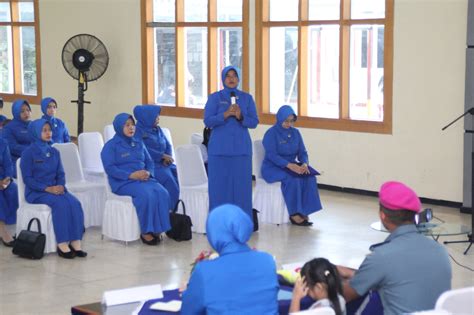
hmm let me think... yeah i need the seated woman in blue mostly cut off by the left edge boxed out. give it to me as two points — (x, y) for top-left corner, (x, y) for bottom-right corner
(0, 139), (18, 247)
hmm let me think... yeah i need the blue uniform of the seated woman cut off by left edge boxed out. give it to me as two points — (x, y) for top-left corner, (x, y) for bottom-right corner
(0, 139), (18, 224)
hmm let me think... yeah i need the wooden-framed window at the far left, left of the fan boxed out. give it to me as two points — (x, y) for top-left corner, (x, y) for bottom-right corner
(0, 0), (41, 103)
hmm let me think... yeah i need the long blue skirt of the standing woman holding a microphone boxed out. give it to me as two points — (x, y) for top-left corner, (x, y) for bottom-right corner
(208, 155), (252, 218)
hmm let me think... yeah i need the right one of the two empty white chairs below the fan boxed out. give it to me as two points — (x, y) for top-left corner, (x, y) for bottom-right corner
(78, 132), (105, 184)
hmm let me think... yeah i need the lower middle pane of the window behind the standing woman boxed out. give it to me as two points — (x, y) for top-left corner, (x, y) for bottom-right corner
(185, 27), (207, 108)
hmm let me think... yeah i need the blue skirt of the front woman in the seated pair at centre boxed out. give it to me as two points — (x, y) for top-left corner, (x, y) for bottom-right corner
(115, 180), (171, 234)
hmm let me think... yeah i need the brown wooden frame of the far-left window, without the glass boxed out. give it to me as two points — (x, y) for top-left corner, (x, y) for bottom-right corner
(0, 0), (42, 104)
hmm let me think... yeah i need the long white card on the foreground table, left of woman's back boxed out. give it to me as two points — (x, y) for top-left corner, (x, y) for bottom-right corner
(102, 284), (163, 306)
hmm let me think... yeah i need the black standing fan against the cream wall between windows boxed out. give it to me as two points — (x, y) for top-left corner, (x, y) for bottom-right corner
(62, 34), (109, 136)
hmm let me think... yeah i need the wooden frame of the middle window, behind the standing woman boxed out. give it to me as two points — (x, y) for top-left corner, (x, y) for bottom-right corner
(141, 0), (249, 119)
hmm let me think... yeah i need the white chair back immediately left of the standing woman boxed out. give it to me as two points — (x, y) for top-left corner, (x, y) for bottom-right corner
(176, 144), (207, 186)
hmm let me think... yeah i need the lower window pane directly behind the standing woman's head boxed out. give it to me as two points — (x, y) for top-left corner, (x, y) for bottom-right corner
(217, 27), (242, 89)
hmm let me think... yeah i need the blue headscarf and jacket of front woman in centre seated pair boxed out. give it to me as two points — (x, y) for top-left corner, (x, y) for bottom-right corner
(100, 113), (154, 192)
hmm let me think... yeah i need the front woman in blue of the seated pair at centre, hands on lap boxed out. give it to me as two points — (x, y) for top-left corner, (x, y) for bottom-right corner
(101, 113), (171, 245)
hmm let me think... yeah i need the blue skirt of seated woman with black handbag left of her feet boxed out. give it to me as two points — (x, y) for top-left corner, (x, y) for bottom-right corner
(27, 192), (84, 243)
